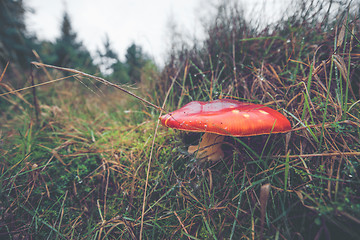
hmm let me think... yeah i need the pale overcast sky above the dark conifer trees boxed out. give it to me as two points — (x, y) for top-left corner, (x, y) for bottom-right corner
(24, 0), (286, 65)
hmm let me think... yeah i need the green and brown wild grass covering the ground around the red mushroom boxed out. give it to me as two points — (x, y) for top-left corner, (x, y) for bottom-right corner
(0, 0), (360, 239)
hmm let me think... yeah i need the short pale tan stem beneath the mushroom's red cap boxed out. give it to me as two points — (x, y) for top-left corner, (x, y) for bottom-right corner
(188, 133), (225, 162)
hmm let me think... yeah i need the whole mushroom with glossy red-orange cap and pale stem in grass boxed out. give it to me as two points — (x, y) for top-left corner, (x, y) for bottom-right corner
(160, 99), (291, 161)
